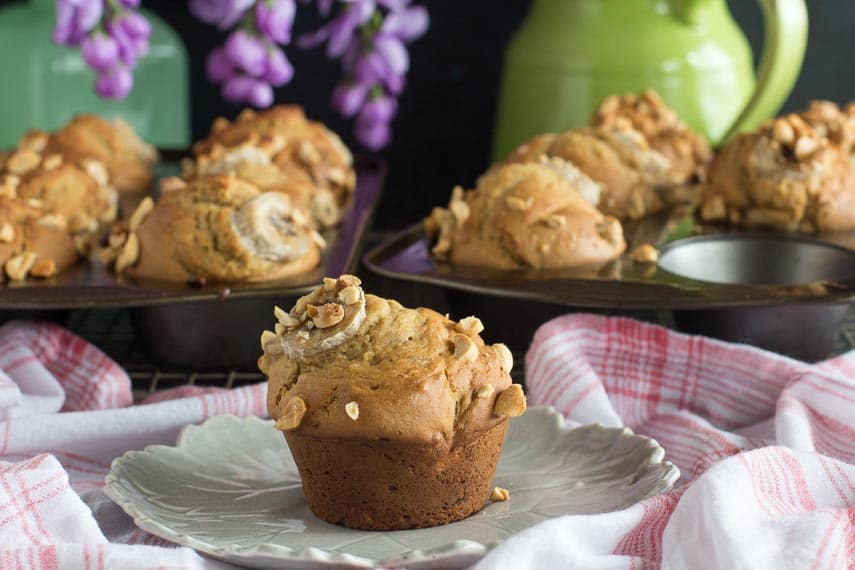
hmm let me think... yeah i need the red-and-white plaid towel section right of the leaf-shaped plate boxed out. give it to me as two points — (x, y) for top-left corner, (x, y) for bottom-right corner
(478, 315), (855, 569)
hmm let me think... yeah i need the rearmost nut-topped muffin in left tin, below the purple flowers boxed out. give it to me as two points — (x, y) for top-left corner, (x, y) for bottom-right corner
(193, 105), (356, 225)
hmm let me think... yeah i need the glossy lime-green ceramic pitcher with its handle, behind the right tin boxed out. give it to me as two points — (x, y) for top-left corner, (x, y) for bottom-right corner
(493, 0), (808, 160)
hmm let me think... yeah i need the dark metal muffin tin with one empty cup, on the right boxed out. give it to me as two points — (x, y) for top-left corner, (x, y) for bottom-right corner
(363, 209), (855, 360)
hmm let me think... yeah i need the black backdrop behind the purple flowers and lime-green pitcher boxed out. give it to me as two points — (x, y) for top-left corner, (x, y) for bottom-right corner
(0, 0), (855, 228)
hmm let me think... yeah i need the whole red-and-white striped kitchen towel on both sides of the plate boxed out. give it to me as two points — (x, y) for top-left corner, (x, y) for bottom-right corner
(0, 315), (855, 569)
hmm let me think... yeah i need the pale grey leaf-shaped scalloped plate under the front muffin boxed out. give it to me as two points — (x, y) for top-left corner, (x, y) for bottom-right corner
(105, 407), (680, 569)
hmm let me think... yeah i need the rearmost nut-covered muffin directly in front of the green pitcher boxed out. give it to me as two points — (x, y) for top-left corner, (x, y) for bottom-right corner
(591, 89), (712, 185)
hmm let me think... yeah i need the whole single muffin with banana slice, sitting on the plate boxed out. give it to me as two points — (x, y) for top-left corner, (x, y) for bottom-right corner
(259, 275), (525, 530)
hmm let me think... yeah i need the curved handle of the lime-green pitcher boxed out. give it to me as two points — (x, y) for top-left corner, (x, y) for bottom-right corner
(722, 0), (808, 143)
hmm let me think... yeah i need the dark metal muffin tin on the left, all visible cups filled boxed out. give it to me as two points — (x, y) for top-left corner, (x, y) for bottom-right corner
(0, 159), (386, 369)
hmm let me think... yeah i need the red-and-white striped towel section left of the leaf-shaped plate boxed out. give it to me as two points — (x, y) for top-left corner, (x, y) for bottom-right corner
(0, 322), (266, 570)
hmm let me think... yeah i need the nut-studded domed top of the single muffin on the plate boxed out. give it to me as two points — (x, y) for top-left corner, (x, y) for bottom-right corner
(259, 275), (525, 449)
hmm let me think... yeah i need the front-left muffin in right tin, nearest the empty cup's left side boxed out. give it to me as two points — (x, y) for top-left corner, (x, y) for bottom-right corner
(426, 159), (626, 269)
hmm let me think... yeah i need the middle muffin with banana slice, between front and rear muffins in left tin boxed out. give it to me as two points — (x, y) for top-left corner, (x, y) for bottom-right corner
(182, 134), (344, 228)
